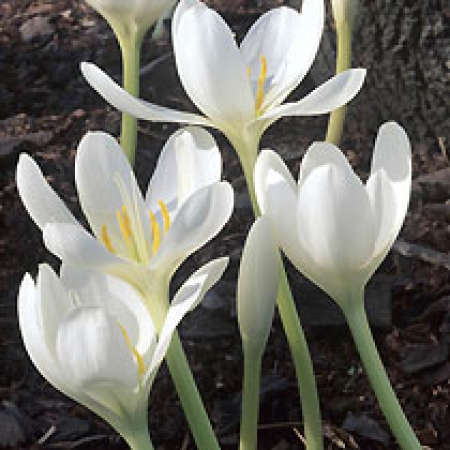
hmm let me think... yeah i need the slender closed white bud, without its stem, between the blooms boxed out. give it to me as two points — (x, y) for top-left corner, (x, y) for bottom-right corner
(237, 216), (280, 349)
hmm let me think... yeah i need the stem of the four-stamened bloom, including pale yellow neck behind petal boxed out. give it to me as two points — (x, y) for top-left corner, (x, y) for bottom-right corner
(140, 289), (220, 450)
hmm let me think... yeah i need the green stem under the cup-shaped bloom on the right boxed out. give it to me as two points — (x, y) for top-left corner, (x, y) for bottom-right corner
(344, 291), (422, 450)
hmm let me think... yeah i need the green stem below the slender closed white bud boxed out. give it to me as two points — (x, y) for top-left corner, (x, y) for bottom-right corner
(239, 345), (263, 450)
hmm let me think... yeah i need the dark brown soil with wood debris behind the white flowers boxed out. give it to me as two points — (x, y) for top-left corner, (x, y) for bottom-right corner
(0, 0), (450, 450)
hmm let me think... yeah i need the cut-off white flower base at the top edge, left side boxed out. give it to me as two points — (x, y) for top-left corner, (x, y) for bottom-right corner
(86, 0), (176, 37)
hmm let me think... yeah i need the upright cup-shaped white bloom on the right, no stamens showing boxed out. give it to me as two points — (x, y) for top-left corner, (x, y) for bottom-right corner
(255, 122), (411, 305)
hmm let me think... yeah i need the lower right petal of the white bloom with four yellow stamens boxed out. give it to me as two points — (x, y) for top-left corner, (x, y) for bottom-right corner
(150, 182), (234, 273)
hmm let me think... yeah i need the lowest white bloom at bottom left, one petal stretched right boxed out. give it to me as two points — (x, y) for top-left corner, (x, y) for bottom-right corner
(18, 258), (227, 440)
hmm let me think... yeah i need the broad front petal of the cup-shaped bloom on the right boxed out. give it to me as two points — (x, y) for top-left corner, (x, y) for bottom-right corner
(297, 165), (377, 300)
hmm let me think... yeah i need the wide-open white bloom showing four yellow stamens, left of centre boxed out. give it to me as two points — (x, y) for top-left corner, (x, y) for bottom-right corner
(17, 127), (233, 290)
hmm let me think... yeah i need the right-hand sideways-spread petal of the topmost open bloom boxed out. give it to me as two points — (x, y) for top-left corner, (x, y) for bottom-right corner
(259, 69), (366, 120)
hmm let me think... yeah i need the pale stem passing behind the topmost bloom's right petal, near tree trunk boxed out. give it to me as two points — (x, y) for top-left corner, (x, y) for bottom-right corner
(326, 23), (353, 145)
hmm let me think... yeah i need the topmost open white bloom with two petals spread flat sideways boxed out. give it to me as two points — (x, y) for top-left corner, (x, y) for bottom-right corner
(82, 0), (365, 151)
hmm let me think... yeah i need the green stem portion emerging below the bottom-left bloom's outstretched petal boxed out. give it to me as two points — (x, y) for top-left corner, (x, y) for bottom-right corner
(166, 332), (220, 450)
